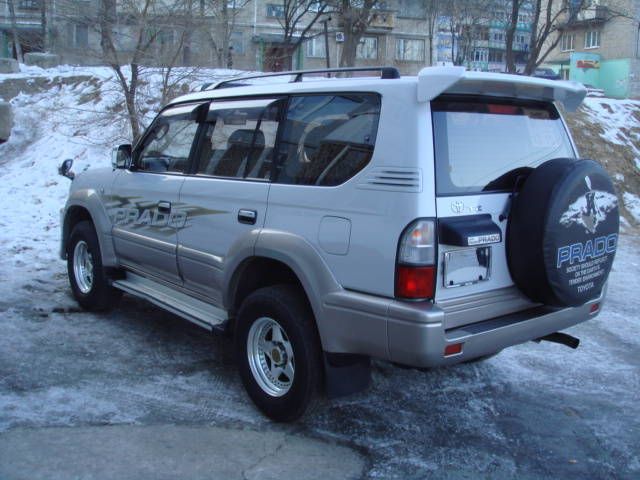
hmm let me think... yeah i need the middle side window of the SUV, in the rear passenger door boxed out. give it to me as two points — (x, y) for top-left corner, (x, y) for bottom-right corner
(197, 99), (281, 179)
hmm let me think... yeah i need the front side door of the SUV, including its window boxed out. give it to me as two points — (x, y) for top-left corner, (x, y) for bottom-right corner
(109, 105), (204, 284)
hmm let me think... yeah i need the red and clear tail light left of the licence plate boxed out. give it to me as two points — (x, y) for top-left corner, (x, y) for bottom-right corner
(395, 220), (437, 300)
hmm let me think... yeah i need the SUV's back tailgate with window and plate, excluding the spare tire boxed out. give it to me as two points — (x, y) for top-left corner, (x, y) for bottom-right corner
(431, 96), (575, 328)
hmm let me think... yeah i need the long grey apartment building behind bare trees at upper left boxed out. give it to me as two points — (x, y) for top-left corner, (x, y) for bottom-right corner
(0, 0), (429, 74)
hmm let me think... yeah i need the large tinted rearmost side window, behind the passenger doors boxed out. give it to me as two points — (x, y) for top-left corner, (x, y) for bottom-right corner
(274, 93), (380, 186)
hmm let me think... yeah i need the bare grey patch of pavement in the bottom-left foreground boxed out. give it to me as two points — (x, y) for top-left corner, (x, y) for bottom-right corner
(0, 425), (364, 480)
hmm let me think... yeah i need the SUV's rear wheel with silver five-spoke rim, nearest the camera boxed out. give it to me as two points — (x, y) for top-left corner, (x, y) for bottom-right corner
(235, 285), (323, 422)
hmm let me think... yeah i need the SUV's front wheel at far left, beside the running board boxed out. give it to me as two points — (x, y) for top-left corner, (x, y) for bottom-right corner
(67, 222), (122, 311)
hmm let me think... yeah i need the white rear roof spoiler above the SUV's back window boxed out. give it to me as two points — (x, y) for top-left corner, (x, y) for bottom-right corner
(418, 67), (587, 111)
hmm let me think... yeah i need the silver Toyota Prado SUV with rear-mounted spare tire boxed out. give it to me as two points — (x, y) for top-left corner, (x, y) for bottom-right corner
(61, 67), (619, 421)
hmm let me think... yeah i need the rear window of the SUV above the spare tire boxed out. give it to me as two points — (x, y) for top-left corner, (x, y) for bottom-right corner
(431, 97), (575, 195)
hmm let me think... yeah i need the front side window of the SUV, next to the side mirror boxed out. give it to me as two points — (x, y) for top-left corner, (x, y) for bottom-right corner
(136, 105), (198, 173)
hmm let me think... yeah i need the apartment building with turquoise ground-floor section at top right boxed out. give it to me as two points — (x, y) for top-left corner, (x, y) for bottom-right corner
(546, 0), (640, 98)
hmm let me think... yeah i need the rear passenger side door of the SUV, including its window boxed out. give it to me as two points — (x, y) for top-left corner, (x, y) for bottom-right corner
(178, 98), (284, 305)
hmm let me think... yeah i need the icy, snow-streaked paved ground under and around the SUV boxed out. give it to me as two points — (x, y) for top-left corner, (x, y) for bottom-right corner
(0, 237), (640, 479)
